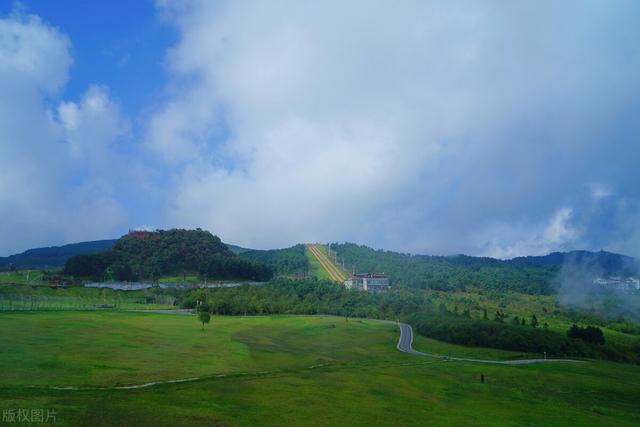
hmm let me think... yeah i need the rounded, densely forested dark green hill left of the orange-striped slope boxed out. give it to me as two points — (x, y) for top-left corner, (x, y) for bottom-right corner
(64, 229), (272, 281)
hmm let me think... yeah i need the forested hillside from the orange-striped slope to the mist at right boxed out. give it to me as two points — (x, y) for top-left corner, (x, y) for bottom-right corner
(331, 243), (559, 294)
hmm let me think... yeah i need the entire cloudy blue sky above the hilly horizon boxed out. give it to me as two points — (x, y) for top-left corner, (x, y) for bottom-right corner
(0, 0), (640, 258)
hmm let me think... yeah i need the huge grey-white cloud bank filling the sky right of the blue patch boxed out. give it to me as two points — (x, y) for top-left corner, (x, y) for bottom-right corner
(145, 0), (640, 257)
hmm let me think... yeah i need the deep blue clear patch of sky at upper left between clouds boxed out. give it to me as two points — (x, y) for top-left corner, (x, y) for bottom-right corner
(0, 0), (178, 116)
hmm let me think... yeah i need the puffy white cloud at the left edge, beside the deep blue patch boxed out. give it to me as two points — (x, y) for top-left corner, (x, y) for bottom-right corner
(0, 13), (126, 254)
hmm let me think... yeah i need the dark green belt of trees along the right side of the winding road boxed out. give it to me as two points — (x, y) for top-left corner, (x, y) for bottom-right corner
(407, 308), (640, 363)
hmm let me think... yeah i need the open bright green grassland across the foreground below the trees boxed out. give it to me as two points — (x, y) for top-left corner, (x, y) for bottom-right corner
(0, 312), (640, 426)
